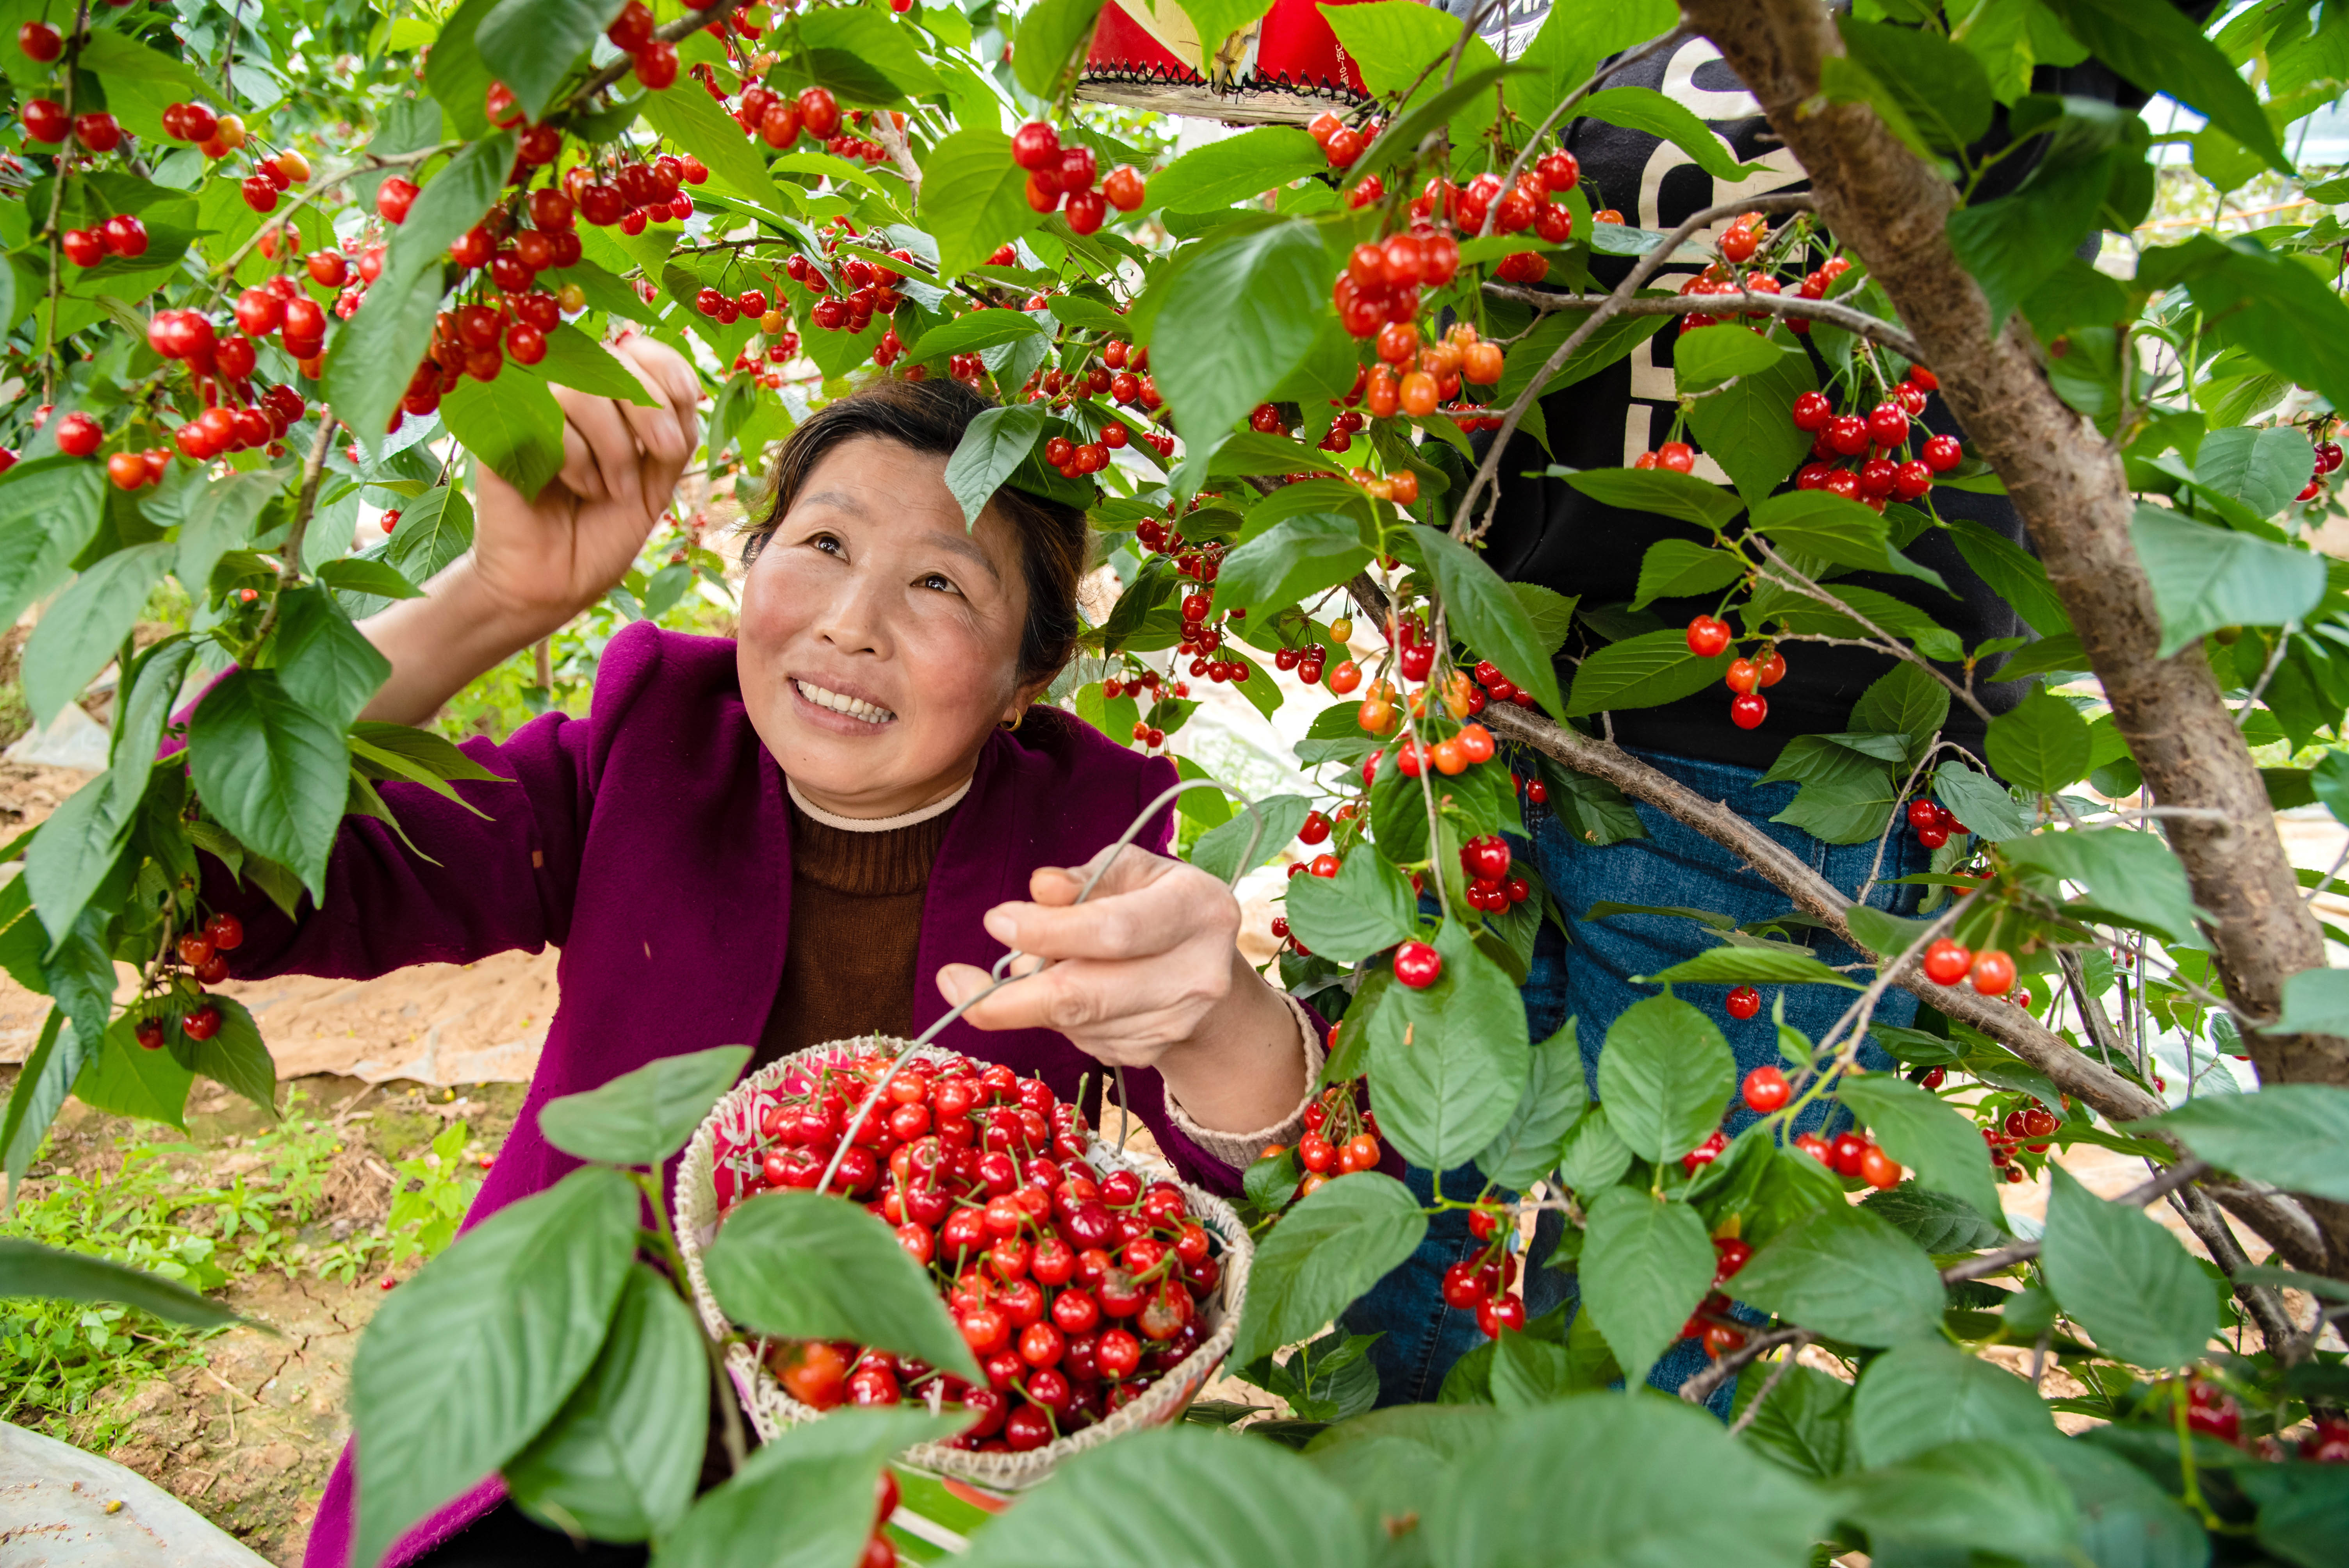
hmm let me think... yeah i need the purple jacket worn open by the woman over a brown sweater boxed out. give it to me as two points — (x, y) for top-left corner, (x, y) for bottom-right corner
(264, 622), (1238, 1568)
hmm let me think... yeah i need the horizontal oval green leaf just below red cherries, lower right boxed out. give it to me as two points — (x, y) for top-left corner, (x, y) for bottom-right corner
(1738, 1192), (1943, 1345)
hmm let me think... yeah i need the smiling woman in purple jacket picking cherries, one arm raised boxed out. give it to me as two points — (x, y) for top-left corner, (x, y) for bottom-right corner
(204, 338), (1322, 1566)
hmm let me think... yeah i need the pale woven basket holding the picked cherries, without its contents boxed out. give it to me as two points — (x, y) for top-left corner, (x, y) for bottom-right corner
(677, 1035), (1255, 1493)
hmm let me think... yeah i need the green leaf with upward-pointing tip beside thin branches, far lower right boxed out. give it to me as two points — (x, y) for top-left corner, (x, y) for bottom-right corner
(2039, 1167), (2217, 1368)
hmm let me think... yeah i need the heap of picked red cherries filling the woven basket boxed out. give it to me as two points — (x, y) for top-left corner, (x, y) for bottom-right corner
(728, 1056), (1224, 1453)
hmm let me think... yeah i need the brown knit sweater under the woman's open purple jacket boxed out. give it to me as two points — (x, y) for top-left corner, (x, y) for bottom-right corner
(754, 800), (961, 1066)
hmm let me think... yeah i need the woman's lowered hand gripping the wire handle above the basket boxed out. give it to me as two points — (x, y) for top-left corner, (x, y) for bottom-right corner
(937, 845), (1304, 1129)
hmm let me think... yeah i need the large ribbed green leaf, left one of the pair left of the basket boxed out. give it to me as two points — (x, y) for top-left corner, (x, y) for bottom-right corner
(350, 1167), (639, 1563)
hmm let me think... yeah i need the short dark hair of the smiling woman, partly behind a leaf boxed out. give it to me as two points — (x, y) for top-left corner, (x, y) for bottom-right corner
(742, 378), (1087, 683)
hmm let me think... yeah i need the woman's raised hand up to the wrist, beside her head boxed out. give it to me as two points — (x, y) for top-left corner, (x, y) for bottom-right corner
(472, 336), (700, 641)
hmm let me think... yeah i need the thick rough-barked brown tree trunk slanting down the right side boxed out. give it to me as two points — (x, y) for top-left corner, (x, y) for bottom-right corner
(1682, 0), (2349, 1265)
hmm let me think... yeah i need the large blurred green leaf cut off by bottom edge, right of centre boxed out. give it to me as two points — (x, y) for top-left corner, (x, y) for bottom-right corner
(1417, 1399), (1830, 1568)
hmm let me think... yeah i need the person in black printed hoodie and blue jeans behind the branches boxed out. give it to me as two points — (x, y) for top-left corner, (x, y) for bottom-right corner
(1344, 0), (2147, 1415)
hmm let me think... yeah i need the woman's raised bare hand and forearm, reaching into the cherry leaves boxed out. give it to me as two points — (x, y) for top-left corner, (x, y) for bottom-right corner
(359, 336), (700, 725)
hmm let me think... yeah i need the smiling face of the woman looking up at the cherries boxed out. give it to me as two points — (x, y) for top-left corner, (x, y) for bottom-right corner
(735, 437), (1034, 817)
